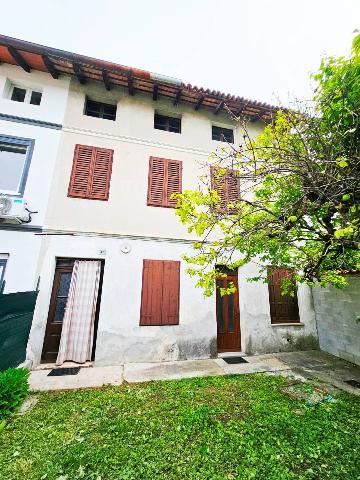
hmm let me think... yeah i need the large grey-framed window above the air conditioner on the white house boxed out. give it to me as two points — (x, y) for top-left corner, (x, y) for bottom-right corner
(0, 136), (34, 196)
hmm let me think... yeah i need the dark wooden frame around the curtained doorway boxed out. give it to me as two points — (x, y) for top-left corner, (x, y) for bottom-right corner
(40, 257), (105, 363)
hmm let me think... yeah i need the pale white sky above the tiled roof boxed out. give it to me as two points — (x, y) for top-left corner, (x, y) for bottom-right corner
(0, 0), (360, 104)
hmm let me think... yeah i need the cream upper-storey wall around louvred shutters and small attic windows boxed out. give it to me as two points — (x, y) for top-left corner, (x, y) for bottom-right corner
(46, 82), (260, 238)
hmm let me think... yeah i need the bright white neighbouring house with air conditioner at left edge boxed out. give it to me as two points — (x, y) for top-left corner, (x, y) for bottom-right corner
(0, 40), (70, 293)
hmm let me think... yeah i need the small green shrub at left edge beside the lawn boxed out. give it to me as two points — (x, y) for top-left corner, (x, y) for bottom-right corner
(0, 368), (29, 421)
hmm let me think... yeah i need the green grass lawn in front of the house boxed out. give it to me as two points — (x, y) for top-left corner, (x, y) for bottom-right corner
(0, 374), (360, 480)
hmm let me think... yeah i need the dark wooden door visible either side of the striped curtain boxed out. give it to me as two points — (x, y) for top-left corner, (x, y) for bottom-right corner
(41, 259), (104, 363)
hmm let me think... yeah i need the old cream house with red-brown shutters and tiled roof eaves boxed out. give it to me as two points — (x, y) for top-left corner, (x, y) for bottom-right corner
(0, 37), (317, 366)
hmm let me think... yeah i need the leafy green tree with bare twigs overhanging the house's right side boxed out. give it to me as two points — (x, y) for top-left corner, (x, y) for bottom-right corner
(177, 35), (360, 294)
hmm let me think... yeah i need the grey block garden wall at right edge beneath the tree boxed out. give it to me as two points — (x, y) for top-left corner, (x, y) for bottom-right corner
(313, 275), (360, 365)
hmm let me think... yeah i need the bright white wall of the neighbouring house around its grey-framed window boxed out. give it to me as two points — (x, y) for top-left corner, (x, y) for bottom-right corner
(0, 64), (69, 293)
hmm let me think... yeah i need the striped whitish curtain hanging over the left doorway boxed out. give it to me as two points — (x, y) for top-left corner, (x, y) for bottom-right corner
(56, 260), (101, 365)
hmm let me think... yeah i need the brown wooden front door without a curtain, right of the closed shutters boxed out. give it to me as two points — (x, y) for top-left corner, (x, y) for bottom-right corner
(216, 271), (241, 352)
